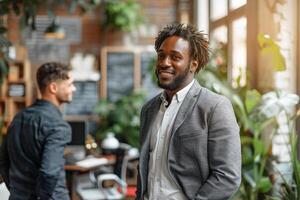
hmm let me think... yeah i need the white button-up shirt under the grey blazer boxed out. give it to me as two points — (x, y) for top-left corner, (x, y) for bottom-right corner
(145, 80), (195, 200)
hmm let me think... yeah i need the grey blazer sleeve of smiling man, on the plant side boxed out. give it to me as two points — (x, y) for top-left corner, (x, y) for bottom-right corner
(195, 98), (241, 200)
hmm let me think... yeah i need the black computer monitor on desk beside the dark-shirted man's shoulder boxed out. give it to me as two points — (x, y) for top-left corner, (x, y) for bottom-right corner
(67, 121), (89, 146)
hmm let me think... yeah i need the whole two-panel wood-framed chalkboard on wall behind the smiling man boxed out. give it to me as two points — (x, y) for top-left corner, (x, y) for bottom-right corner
(100, 46), (161, 102)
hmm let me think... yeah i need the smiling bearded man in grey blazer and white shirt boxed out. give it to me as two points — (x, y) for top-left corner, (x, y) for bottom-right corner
(137, 24), (241, 200)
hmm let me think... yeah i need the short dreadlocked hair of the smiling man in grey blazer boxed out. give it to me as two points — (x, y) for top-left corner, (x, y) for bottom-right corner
(155, 24), (210, 73)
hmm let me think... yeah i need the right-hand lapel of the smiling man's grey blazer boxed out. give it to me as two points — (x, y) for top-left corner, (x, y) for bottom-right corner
(172, 81), (201, 135)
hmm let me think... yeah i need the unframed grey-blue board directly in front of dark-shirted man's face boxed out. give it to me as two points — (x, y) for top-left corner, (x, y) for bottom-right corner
(64, 81), (99, 115)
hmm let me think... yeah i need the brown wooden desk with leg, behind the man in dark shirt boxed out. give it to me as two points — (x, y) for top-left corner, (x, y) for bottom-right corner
(64, 156), (116, 200)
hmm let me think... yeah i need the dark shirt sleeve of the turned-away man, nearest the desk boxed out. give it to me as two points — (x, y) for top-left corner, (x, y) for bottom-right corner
(37, 124), (69, 199)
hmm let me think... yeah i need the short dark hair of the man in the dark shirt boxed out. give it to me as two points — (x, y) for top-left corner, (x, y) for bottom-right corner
(36, 62), (71, 93)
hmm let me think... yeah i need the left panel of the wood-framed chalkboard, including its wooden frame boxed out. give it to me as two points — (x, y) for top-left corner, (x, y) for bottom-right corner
(100, 47), (140, 102)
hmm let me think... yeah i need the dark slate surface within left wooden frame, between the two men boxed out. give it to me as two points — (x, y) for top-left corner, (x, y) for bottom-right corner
(107, 52), (134, 102)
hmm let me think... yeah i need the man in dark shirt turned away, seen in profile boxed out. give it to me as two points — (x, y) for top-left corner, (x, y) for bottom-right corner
(0, 62), (76, 200)
